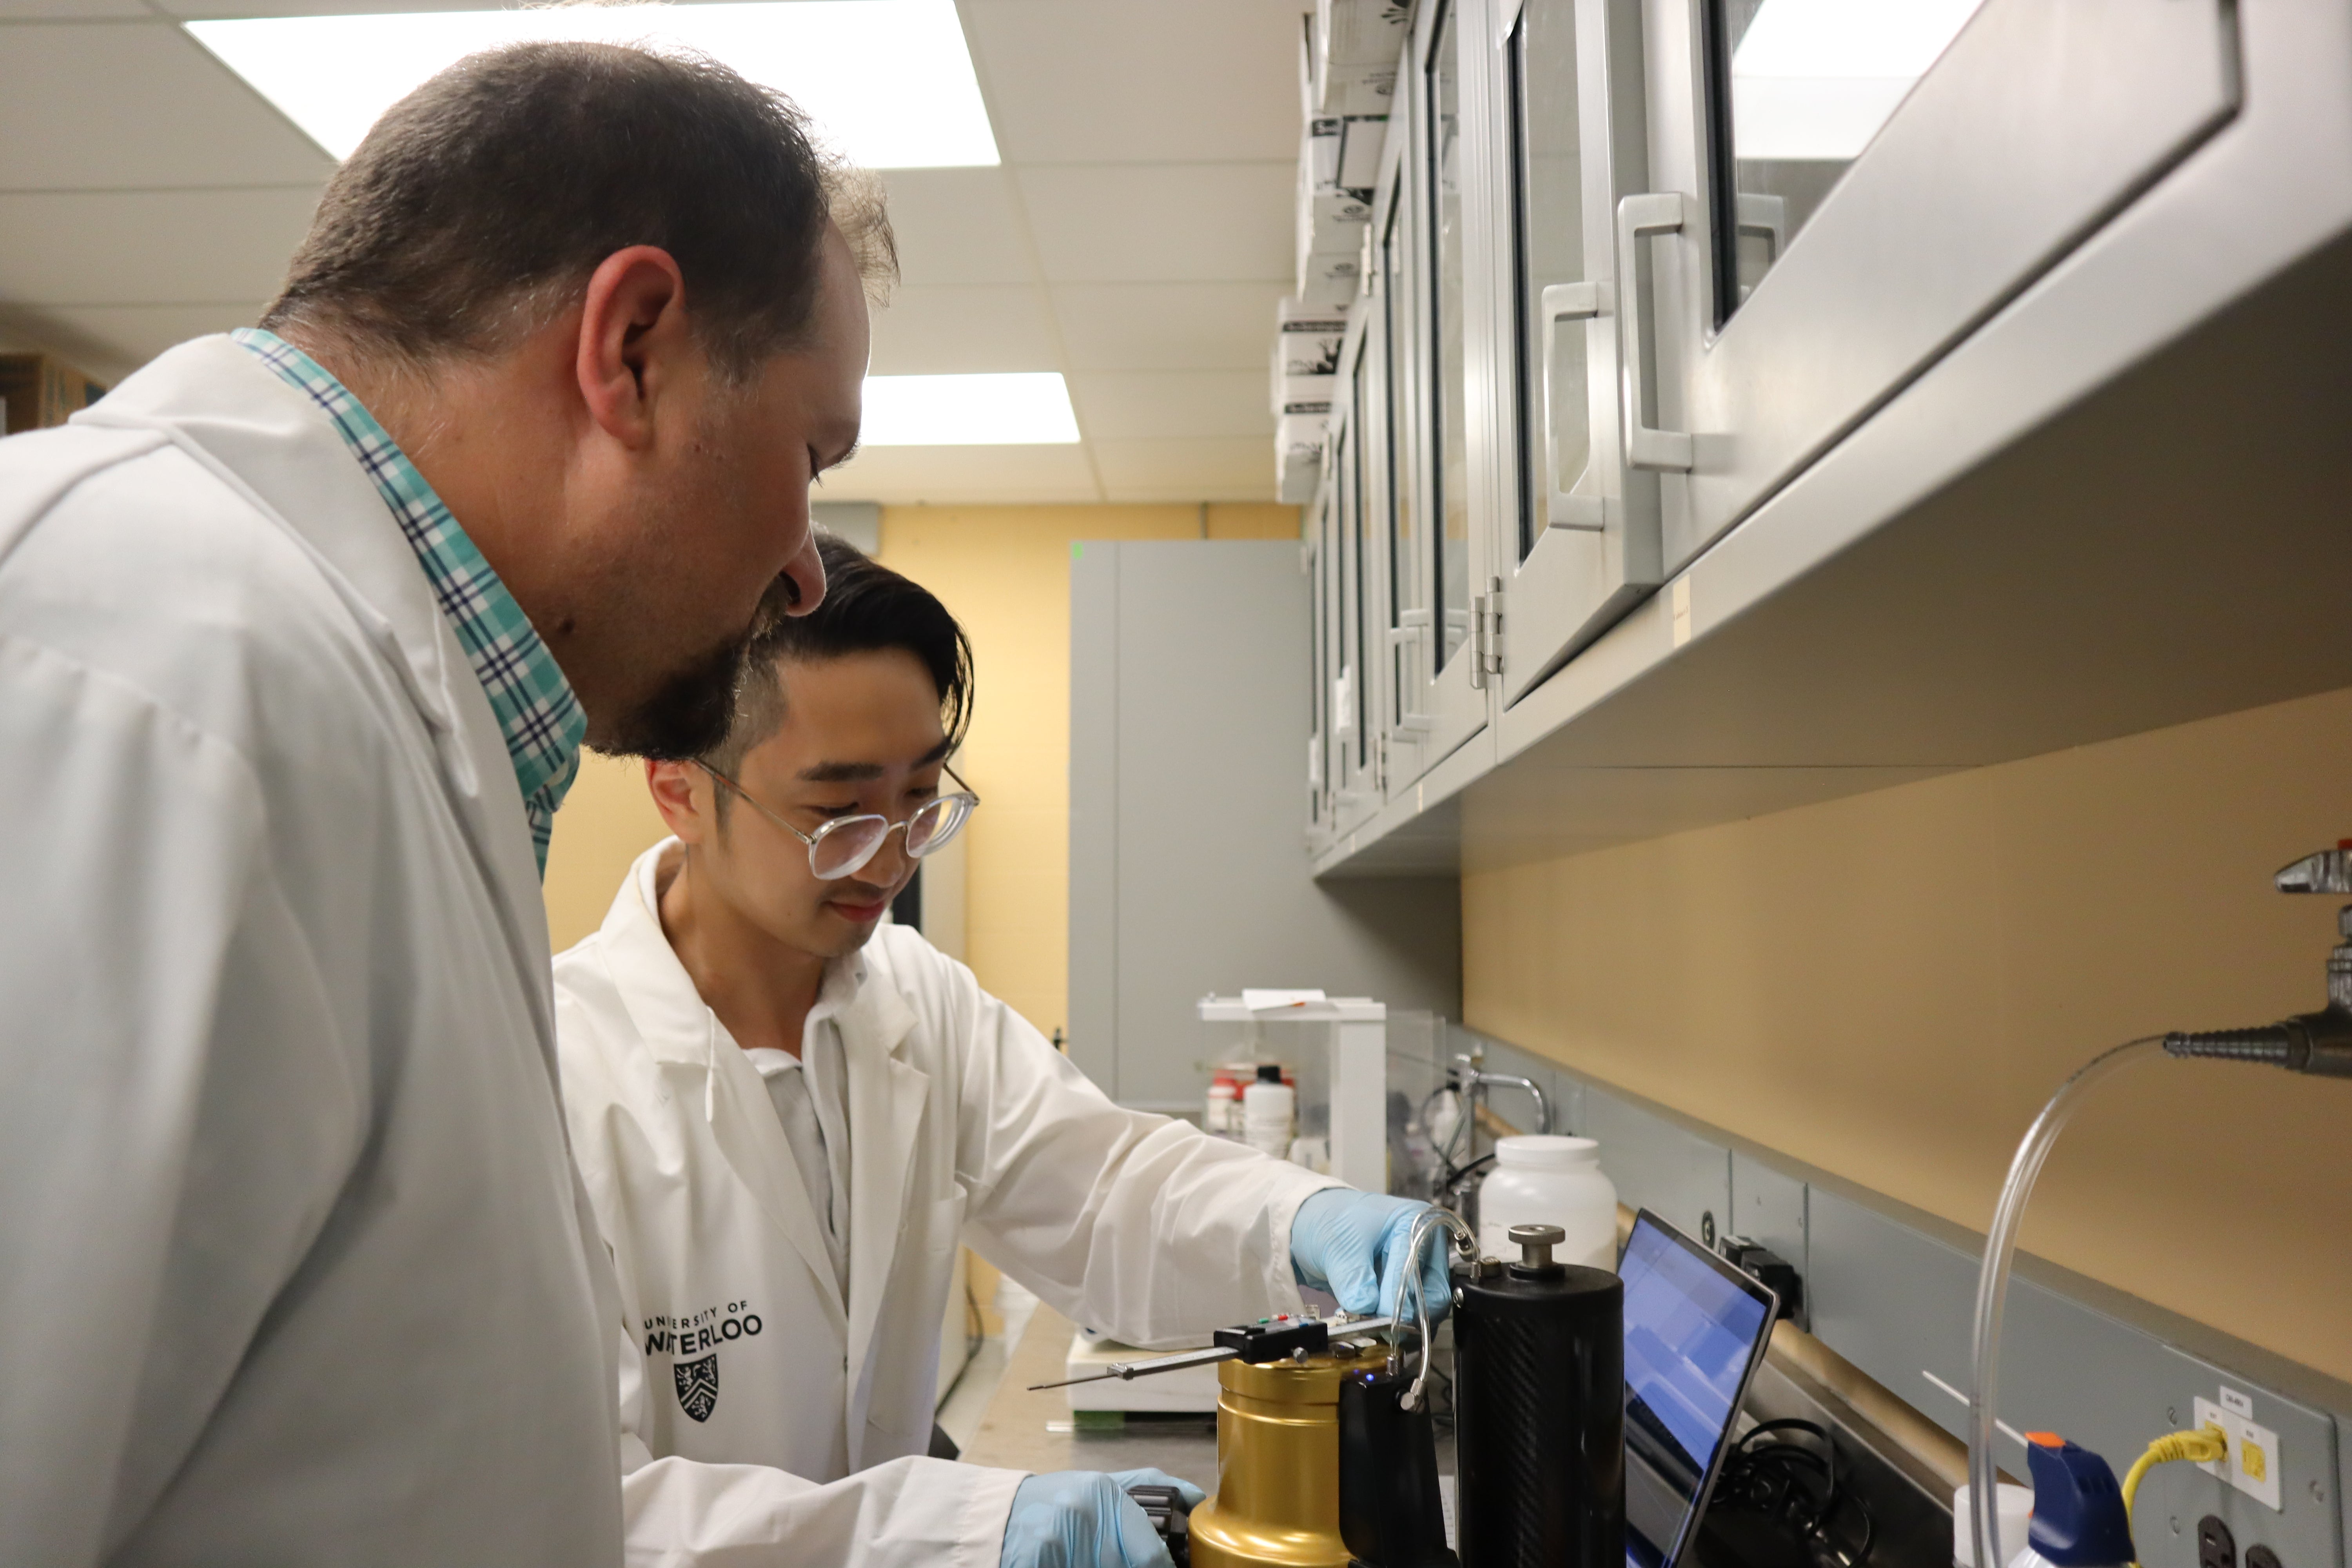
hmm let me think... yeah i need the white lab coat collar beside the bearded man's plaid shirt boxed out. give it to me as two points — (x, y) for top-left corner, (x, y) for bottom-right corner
(73, 336), (555, 1029)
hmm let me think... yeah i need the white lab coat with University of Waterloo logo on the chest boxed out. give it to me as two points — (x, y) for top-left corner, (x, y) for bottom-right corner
(555, 839), (1338, 1568)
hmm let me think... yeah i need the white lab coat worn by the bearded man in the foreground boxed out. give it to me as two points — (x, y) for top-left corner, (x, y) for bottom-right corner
(0, 339), (621, 1568)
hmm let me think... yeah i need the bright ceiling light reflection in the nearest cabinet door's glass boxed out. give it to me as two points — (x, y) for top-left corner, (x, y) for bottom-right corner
(1731, 0), (1983, 162)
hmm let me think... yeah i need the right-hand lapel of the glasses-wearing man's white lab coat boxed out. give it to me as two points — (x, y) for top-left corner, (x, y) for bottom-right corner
(840, 964), (931, 1469)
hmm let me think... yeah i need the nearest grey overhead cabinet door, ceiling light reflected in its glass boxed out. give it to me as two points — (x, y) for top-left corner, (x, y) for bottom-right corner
(1613, 0), (2239, 573)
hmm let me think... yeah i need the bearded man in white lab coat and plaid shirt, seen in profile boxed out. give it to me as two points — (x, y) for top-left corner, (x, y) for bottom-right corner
(0, 45), (873, 1568)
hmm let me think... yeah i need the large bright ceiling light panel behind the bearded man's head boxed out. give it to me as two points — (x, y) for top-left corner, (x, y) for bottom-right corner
(183, 0), (997, 169)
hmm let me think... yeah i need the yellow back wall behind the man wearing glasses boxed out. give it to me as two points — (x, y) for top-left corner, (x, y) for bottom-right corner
(548, 505), (1298, 1032)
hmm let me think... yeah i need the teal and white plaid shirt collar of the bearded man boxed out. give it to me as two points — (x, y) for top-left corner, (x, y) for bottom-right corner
(228, 327), (588, 877)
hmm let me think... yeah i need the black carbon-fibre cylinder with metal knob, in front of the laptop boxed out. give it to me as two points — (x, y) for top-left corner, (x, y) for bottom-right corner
(1454, 1232), (1625, 1568)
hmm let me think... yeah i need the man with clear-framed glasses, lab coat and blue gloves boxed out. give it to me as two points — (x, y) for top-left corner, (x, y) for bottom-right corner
(555, 538), (1444, 1568)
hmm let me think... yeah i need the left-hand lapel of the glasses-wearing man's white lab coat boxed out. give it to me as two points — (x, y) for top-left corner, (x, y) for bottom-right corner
(602, 839), (847, 1335)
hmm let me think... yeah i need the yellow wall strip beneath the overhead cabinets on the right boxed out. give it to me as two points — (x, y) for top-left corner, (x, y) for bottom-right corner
(1463, 691), (2352, 1377)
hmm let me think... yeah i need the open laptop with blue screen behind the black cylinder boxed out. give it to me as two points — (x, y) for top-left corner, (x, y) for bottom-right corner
(1618, 1208), (1780, 1568)
